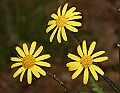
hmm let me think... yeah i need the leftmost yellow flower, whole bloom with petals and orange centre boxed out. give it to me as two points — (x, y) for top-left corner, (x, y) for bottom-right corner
(11, 41), (51, 84)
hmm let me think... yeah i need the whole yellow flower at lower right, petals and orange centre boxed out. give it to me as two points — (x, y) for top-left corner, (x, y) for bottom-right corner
(66, 40), (108, 84)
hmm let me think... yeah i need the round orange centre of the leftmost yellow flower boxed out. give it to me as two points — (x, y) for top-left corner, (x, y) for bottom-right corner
(22, 55), (36, 69)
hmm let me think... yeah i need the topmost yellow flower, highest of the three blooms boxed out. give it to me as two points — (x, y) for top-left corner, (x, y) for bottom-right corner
(46, 3), (82, 43)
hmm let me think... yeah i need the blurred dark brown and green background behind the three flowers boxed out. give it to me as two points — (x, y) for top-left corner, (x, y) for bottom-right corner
(0, 0), (119, 93)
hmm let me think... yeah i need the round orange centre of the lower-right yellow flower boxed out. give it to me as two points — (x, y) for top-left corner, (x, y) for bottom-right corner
(80, 56), (92, 68)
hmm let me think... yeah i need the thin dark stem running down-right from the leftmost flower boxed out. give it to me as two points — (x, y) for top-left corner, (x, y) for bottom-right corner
(47, 72), (73, 93)
